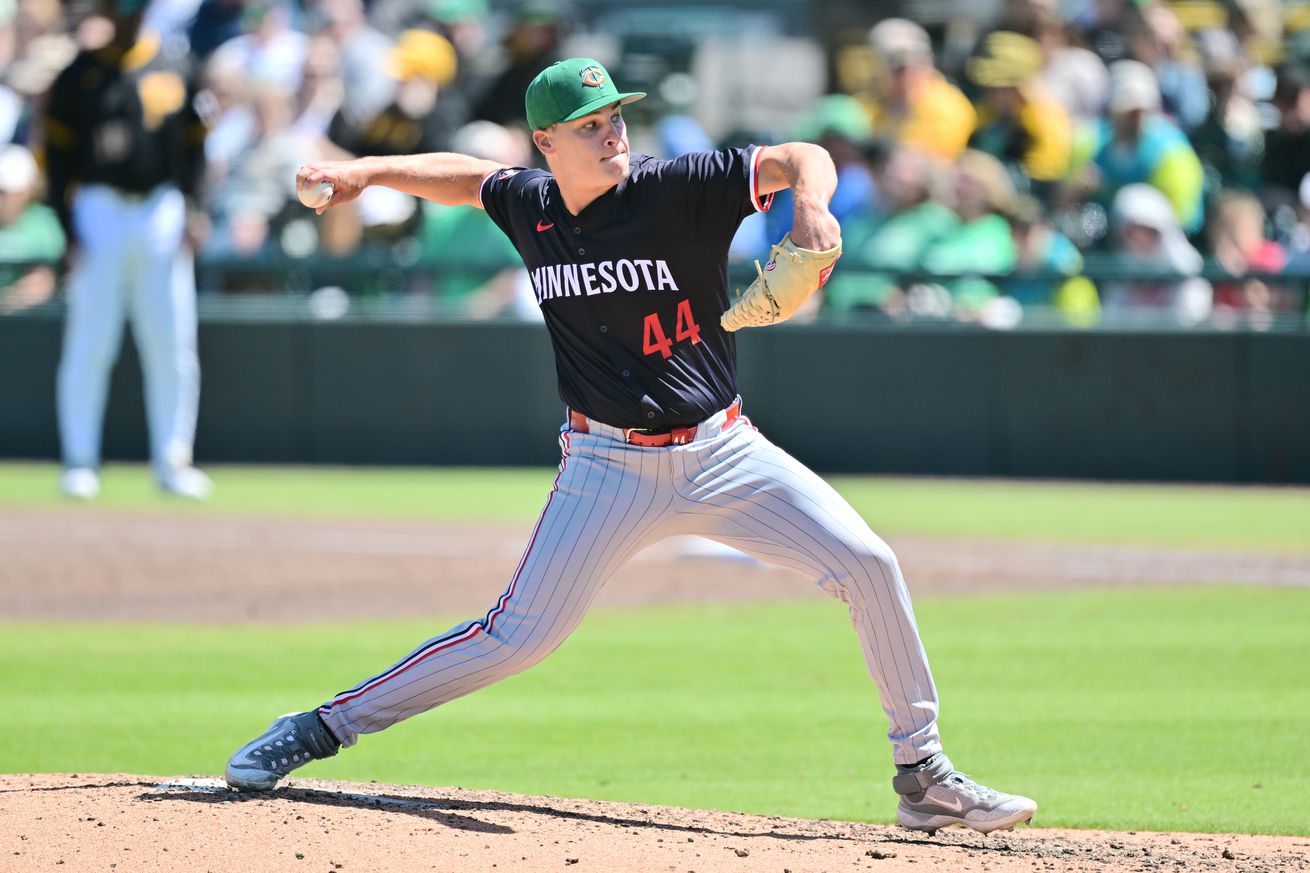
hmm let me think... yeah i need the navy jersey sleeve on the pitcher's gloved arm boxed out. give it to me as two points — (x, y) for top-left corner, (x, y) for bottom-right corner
(660, 146), (773, 240)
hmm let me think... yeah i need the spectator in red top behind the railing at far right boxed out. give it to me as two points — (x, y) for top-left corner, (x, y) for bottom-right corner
(1207, 193), (1296, 329)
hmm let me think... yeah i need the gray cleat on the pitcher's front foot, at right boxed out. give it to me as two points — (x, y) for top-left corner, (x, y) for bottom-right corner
(892, 754), (1038, 836)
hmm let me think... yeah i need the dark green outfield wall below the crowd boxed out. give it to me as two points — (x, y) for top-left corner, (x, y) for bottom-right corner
(0, 316), (1310, 482)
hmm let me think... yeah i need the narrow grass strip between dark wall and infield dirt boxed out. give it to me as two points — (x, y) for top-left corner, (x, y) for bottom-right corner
(0, 464), (1310, 552)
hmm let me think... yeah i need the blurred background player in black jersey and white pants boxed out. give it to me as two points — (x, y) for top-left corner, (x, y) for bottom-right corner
(45, 0), (210, 499)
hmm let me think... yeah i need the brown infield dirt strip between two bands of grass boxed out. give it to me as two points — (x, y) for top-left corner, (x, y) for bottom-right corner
(0, 507), (1310, 623)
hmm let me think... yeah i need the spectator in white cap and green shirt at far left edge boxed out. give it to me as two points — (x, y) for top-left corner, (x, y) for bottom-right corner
(0, 146), (67, 315)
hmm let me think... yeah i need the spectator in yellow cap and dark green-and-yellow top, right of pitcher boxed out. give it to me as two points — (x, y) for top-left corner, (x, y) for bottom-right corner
(968, 30), (1073, 190)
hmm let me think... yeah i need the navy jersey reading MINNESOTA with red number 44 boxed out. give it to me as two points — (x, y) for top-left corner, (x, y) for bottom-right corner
(479, 147), (772, 430)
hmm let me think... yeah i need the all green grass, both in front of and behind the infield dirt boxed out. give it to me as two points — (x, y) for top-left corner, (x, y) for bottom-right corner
(0, 465), (1310, 835)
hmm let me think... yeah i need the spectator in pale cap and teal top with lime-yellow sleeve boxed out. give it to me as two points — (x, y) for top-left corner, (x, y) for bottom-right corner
(1081, 60), (1205, 233)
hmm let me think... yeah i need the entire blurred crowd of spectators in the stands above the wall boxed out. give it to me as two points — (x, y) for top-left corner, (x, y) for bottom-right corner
(0, 0), (1310, 329)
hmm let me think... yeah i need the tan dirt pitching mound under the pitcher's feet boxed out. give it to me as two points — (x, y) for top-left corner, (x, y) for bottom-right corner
(0, 775), (1310, 873)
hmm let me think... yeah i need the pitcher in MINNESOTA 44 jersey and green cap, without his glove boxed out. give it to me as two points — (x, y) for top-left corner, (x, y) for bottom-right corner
(227, 58), (1036, 831)
